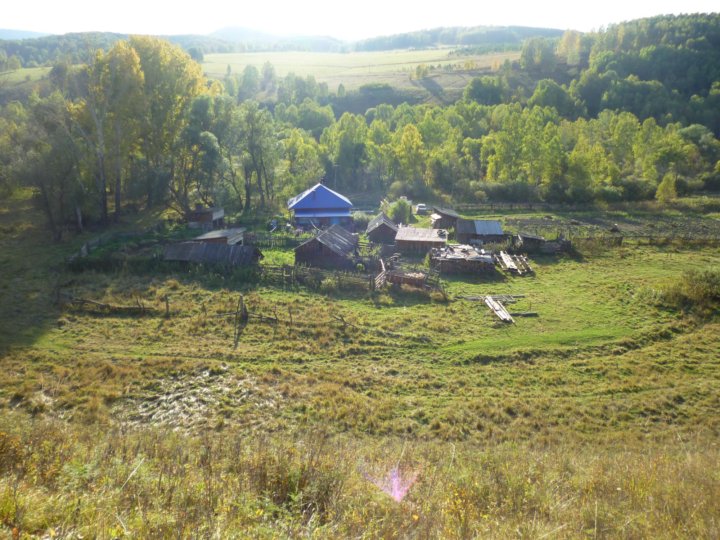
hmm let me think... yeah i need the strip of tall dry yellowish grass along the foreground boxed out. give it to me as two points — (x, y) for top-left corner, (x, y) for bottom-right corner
(0, 414), (720, 538)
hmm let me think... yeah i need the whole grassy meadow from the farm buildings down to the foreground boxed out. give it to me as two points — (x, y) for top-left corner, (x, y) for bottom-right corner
(0, 190), (720, 538)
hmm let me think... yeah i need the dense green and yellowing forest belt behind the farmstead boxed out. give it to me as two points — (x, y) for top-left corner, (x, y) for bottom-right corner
(0, 15), (720, 238)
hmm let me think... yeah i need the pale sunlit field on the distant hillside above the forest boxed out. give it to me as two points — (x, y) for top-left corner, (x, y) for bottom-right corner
(203, 49), (520, 92)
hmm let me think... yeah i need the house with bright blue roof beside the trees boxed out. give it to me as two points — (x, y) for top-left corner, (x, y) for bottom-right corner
(288, 184), (353, 229)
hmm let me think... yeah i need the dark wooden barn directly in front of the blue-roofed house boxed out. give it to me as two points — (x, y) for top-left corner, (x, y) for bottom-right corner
(295, 225), (358, 270)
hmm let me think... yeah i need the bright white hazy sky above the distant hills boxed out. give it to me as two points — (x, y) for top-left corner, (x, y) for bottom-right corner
(5, 0), (720, 40)
